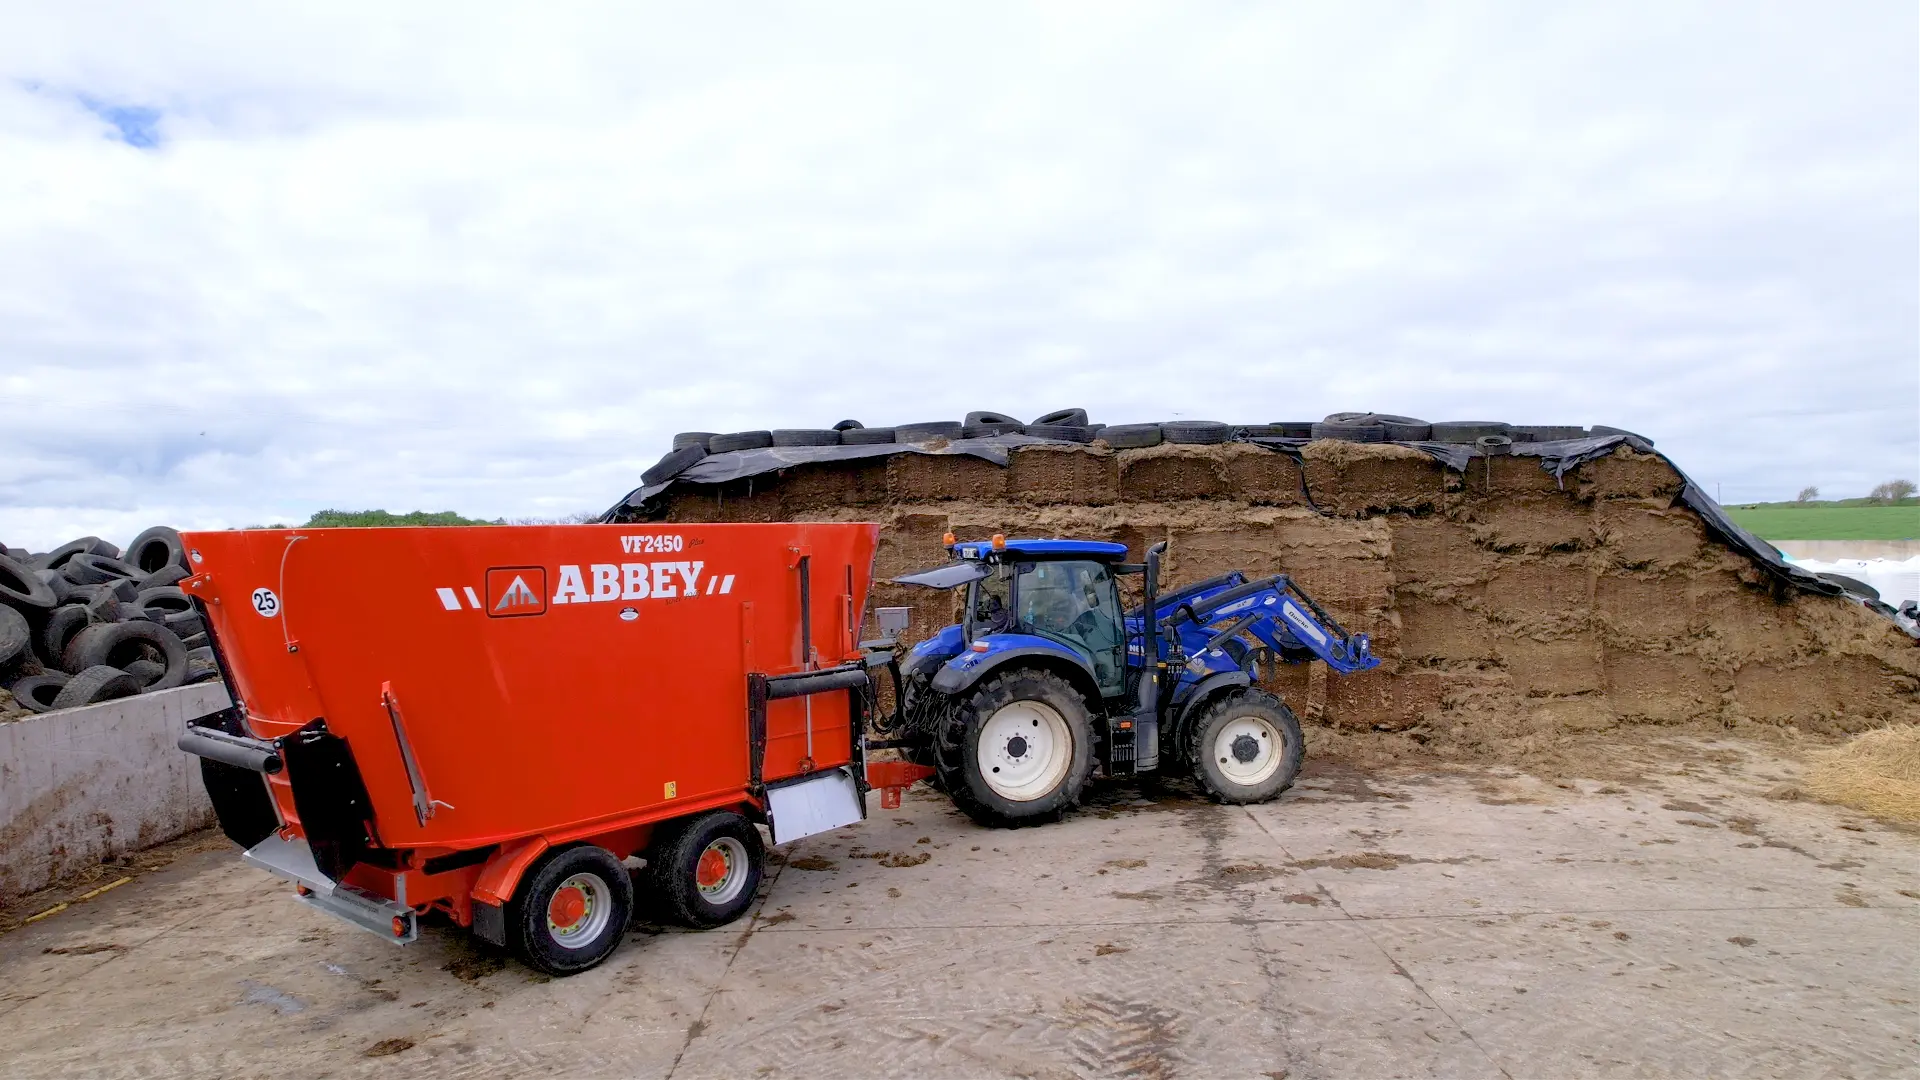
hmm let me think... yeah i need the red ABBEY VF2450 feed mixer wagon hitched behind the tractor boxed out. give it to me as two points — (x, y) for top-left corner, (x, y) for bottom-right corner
(180, 523), (925, 974)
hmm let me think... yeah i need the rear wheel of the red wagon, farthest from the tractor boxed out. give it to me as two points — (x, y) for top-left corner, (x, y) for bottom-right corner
(507, 844), (634, 974)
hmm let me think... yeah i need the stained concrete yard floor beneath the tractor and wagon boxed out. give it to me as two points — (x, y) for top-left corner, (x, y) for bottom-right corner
(0, 740), (1920, 1080)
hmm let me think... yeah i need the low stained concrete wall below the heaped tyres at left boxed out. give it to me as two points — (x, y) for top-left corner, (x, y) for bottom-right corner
(0, 682), (228, 896)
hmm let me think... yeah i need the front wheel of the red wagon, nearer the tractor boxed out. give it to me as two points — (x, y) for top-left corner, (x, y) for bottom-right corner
(645, 811), (766, 930)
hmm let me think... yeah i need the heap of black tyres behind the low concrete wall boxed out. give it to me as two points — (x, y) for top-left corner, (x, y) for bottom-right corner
(0, 527), (219, 713)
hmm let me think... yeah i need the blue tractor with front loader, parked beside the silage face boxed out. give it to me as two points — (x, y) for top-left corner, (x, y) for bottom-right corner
(868, 534), (1380, 824)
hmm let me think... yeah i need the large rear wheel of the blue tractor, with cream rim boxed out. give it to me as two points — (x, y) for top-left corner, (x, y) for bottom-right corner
(935, 667), (1092, 826)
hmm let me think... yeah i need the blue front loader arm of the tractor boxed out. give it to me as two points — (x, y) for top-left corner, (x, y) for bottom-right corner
(1160, 575), (1380, 675)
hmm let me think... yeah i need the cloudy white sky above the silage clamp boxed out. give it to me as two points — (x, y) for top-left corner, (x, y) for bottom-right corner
(0, 0), (1920, 550)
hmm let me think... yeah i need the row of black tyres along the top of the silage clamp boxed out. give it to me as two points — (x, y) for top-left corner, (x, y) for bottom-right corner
(639, 409), (1651, 486)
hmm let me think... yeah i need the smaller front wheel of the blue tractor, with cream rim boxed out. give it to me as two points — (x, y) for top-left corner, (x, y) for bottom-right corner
(1187, 690), (1306, 803)
